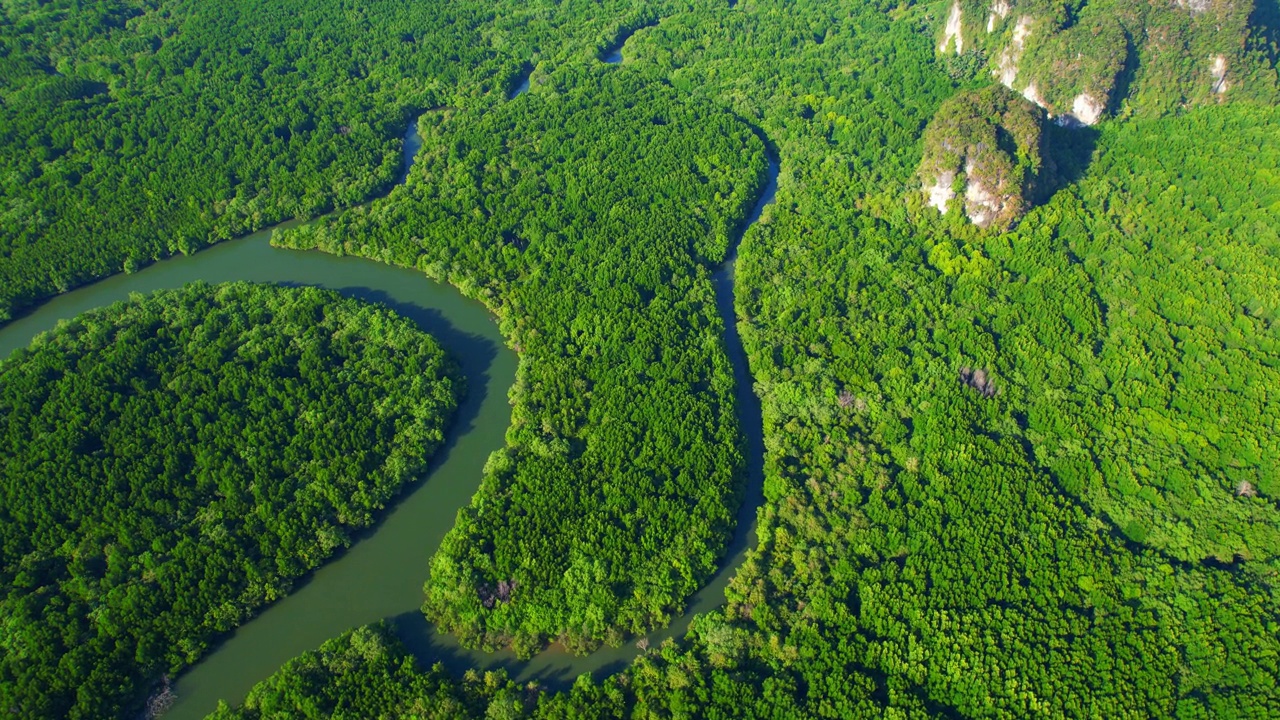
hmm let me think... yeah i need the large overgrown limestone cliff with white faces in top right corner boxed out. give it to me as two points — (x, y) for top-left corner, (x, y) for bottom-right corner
(934, 0), (1276, 124)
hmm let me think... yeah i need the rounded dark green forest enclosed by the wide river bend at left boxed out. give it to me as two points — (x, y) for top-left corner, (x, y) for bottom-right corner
(0, 283), (461, 719)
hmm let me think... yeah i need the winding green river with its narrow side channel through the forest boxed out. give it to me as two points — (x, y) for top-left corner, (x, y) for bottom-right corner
(0, 54), (778, 720)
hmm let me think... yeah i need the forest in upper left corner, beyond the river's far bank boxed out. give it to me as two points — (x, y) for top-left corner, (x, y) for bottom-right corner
(0, 0), (675, 318)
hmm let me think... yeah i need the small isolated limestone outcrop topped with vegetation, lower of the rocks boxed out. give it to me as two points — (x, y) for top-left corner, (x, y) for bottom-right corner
(919, 86), (1043, 228)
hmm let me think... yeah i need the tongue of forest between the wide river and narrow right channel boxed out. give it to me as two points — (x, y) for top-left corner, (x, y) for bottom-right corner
(276, 64), (765, 652)
